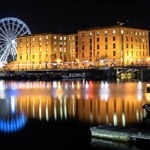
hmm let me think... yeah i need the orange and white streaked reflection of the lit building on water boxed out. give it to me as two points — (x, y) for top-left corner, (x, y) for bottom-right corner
(0, 80), (150, 130)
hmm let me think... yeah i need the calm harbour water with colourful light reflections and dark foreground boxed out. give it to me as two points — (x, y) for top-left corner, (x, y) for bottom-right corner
(0, 80), (150, 150)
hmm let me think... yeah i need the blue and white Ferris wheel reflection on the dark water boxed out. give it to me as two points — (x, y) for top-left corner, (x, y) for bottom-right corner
(0, 97), (27, 133)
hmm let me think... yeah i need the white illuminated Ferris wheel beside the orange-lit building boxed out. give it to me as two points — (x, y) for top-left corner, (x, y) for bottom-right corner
(0, 17), (31, 63)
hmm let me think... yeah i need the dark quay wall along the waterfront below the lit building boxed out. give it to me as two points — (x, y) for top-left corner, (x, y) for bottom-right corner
(0, 66), (150, 80)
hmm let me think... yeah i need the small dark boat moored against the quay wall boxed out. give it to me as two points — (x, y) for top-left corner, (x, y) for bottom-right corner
(62, 73), (85, 79)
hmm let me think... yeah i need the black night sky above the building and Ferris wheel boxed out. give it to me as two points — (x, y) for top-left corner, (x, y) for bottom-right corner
(0, 0), (150, 33)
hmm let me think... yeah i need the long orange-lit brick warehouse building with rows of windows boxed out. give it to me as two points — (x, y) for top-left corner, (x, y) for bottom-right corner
(7, 26), (150, 70)
